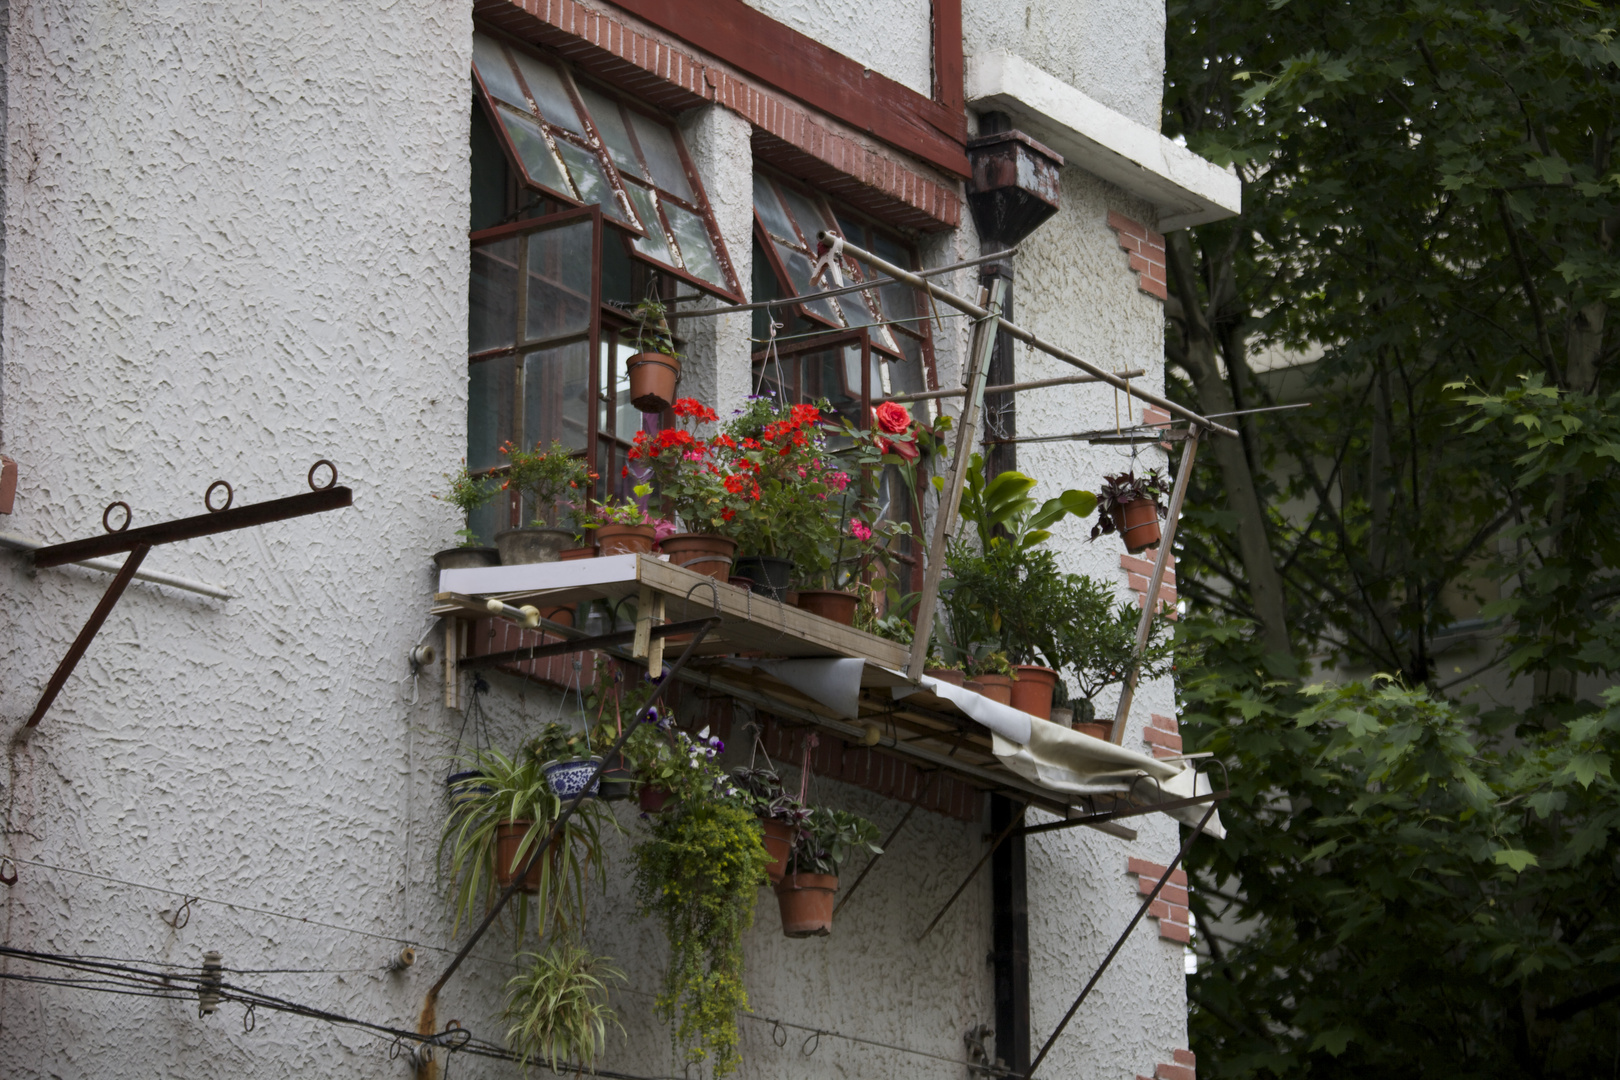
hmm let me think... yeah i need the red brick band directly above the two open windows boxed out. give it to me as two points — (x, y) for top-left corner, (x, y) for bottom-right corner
(473, 0), (959, 233)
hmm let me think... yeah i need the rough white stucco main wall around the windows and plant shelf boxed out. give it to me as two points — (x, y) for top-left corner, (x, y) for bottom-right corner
(0, 0), (1184, 1080)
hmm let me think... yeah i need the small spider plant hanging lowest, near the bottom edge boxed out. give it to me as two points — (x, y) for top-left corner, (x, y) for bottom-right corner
(505, 941), (625, 1074)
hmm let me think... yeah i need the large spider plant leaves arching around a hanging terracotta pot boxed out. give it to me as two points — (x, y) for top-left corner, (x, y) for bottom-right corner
(439, 746), (616, 938)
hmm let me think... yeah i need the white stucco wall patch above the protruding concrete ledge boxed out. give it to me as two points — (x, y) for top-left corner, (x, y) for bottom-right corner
(962, 0), (1165, 131)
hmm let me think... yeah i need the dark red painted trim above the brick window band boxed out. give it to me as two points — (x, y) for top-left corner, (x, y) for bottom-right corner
(612, 0), (969, 178)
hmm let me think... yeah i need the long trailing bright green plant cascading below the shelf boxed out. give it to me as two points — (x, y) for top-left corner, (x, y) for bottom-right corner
(635, 777), (771, 1077)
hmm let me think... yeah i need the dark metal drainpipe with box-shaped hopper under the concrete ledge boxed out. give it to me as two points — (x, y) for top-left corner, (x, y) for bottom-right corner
(967, 112), (1063, 1075)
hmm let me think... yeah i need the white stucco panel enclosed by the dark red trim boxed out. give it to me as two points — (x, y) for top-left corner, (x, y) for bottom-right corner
(745, 0), (933, 97)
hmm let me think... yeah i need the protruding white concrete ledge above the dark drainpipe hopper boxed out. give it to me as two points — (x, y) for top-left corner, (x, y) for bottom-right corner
(966, 52), (1243, 233)
